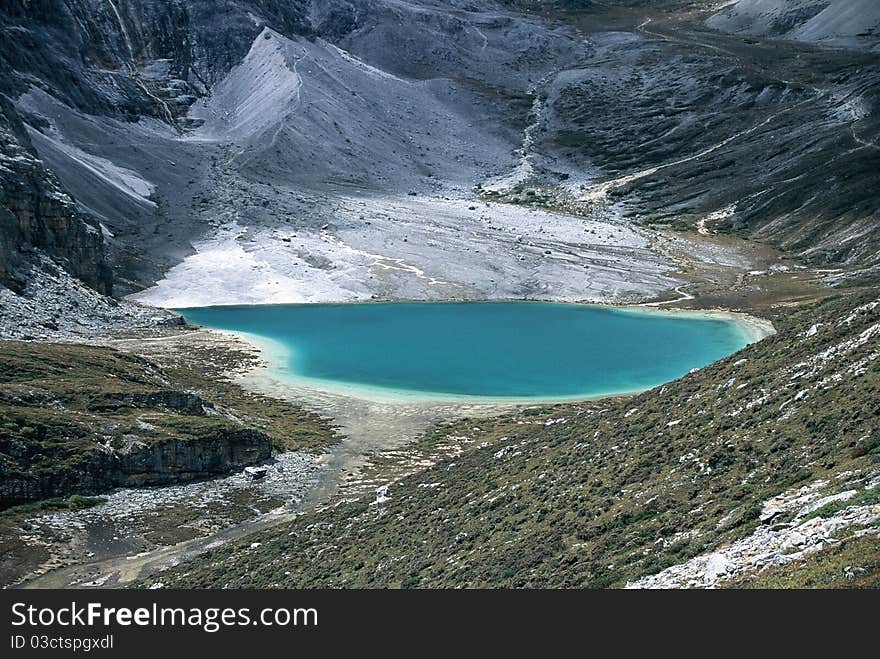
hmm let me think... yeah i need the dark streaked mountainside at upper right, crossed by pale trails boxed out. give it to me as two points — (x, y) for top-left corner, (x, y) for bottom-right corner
(492, 0), (880, 282)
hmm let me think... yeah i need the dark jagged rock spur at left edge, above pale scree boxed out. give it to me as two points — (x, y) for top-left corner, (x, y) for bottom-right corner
(0, 95), (112, 294)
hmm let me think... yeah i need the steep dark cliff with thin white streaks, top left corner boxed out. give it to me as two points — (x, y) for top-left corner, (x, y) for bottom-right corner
(0, 0), (312, 121)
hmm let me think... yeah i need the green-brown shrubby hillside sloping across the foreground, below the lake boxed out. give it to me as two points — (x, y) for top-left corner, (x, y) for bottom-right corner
(156, 291), (880, 588)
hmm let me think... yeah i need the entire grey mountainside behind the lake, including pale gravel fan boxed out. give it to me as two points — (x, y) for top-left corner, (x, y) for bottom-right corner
(0, 0), (880, 320)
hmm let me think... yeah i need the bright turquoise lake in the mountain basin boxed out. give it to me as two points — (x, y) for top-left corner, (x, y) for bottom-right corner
(178, 302), (749, 399)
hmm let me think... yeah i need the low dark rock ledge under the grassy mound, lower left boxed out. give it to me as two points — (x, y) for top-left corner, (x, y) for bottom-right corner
(0, 429), (272, 507)
